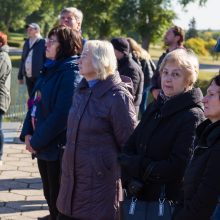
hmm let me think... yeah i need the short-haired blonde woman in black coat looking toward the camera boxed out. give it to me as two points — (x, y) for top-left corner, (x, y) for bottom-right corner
(119, 49), (204, 215)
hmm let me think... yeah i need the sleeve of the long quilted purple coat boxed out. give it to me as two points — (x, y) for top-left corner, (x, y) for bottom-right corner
(110, 89), (137, 148)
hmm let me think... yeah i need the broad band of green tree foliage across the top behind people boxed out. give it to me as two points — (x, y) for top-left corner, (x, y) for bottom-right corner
(0, 0), (207, 49)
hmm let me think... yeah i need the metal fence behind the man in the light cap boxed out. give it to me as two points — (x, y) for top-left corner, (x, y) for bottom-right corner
(4, 68), (28, 122)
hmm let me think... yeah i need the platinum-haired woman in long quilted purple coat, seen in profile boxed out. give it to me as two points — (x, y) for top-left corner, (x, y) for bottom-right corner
(57, 40), (136, 220)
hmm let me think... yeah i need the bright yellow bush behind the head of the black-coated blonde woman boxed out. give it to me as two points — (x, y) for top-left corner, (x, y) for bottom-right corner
(184, 38), (208, 56)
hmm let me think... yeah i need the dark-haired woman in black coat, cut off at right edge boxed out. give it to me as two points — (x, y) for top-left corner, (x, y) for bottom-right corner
(174, 75), (220, 220)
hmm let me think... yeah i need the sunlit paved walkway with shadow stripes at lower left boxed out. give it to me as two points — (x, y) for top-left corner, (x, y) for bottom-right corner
(0, 123), (48, 220)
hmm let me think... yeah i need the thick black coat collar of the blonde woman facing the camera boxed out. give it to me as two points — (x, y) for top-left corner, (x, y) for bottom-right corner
(155, 88), (203, 117)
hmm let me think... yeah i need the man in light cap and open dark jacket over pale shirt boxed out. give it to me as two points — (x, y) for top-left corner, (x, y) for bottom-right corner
(18, 23), (45, 97)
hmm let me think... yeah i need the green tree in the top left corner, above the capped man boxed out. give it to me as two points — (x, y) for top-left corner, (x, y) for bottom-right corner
(0, 0), (41, 31)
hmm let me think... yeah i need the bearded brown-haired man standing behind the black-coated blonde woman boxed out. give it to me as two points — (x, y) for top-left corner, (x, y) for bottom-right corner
(150, 26), (184, 99)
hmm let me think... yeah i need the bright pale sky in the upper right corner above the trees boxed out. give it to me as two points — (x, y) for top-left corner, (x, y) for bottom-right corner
(173, 0), (220, 30)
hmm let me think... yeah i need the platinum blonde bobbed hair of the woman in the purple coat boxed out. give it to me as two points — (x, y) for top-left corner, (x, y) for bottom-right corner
(83, 40), (117, 80)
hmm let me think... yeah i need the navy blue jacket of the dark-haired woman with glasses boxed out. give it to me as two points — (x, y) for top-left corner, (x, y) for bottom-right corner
(20, 56), (81, 161)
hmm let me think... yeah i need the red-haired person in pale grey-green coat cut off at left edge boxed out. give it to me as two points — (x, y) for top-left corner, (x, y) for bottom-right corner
(0, 32), (12, 165)
